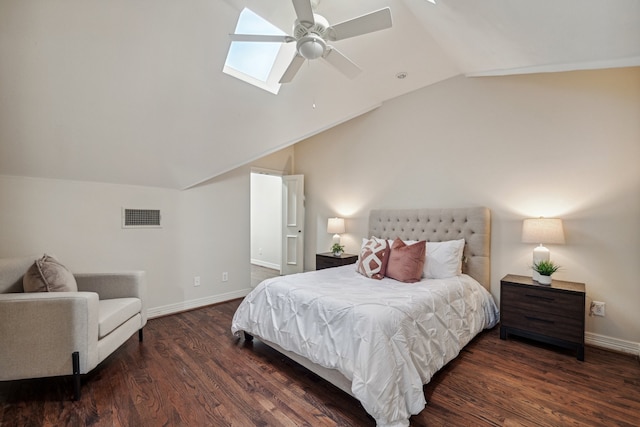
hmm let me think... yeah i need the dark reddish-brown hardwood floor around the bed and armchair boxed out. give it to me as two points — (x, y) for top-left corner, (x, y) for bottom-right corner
(0, 300), (640, 427)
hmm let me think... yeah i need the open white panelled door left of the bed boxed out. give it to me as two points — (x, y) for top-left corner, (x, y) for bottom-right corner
(280, 175), (304, 275)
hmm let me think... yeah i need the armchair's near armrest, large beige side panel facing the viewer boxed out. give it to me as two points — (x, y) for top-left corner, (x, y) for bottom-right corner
(0, 292), (99, 381)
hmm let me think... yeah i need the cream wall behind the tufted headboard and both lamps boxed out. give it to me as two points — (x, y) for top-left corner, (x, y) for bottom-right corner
(295, 68), (640, 348)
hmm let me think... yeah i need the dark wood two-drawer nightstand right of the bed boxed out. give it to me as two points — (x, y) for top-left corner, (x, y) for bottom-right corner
(500, 274), (585, 360)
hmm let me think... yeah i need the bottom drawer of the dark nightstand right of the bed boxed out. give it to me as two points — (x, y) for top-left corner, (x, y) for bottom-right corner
(500, 307), (584, 342)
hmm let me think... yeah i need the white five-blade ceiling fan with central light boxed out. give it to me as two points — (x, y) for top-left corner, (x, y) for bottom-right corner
(230, 0), (392, 83)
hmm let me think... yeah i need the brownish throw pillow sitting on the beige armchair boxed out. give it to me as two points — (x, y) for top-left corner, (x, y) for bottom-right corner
(22, 254), (78, 292)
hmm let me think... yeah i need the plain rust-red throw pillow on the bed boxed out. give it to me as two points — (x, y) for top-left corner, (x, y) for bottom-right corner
(386, 238), (427, 283)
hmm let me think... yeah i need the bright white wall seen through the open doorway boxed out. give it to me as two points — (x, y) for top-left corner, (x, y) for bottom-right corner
(251, 173), (282, 270)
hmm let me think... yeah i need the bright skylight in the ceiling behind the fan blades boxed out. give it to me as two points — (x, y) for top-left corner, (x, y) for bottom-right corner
(223, 8), (291, 94)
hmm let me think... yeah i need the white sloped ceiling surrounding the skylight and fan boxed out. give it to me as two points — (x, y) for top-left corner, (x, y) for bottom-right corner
(0, 0), (640, 189)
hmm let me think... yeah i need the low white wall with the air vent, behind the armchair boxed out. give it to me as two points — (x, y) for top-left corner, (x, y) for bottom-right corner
(0, 176), (184, 307)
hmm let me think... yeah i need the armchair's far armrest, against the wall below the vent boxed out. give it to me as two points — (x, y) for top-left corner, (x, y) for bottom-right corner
(74, 271), (147, 326)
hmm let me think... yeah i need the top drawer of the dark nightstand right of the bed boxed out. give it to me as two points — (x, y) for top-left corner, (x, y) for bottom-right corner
(501, 283), (584, 319)
